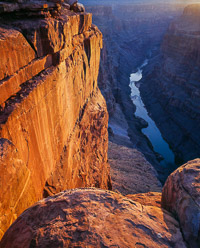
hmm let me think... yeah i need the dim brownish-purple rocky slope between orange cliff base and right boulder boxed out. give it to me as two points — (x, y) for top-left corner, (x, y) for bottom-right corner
(108, 142), (162, 195)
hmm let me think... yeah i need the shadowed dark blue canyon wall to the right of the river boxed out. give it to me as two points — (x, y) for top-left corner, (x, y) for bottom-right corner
(140, 4), (200, 163)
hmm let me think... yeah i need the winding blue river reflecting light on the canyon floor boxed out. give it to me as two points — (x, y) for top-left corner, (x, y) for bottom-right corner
(130, 59), (175, 167)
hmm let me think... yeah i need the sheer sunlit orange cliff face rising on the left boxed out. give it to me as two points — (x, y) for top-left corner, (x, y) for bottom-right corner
(0, 2), (111, 236)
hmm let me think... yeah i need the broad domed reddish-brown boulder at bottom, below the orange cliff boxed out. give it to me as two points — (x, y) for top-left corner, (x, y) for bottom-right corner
(0, 188), (186, 248)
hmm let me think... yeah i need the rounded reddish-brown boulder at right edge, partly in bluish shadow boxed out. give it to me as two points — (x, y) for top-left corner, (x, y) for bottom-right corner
(162, 159), (200, 248)
